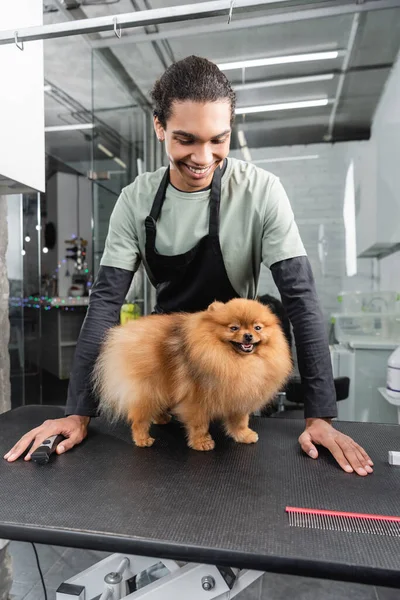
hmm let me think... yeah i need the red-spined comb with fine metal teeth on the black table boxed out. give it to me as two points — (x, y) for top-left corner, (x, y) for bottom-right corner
(286, 506), (400, 537)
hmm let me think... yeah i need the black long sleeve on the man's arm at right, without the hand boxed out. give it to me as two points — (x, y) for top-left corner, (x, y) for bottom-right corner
(271, 256), (337, 418)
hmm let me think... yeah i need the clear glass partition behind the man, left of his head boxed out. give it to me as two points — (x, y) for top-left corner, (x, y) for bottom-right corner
(90, 50), (161, 314)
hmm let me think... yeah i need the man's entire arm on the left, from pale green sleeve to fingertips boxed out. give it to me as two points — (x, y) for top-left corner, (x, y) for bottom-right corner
(4, 185), (141, 462)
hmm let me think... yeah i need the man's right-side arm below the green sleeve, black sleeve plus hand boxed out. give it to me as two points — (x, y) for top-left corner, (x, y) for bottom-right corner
(271, 256), (373, 475)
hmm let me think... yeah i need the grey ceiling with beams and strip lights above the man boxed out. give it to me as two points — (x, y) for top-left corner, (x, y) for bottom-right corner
(39, 0), (400, 162)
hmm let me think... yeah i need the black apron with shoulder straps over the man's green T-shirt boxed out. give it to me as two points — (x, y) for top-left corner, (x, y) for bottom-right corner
(144, 167), (240, 314)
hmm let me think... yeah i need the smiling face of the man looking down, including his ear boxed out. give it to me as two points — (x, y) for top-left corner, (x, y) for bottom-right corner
(154, 100), (231, 192)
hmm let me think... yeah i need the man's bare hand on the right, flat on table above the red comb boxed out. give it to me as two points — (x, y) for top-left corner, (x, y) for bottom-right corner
(299, 419), (374, 475)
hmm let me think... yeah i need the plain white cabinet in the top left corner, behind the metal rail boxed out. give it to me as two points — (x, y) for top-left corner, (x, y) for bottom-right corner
(0, 0), (45, 191)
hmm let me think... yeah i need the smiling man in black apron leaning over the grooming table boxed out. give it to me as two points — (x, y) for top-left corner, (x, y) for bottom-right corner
(6, 56), (372, 475)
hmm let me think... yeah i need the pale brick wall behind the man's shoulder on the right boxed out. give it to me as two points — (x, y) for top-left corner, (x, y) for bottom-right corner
(231, 142), (374, 325)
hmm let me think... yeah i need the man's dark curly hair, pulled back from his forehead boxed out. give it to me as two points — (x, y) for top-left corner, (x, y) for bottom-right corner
(150, 56), (236, 129)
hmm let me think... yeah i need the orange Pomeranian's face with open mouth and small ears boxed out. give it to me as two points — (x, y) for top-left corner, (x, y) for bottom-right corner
(207, 298), (277, 355)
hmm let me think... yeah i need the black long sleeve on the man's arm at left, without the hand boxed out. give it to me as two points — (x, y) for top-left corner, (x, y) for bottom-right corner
(65, 266), (133, 417)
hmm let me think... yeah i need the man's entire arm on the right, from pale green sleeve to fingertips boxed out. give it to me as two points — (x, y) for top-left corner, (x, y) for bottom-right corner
(262, 178), (372, 475)
